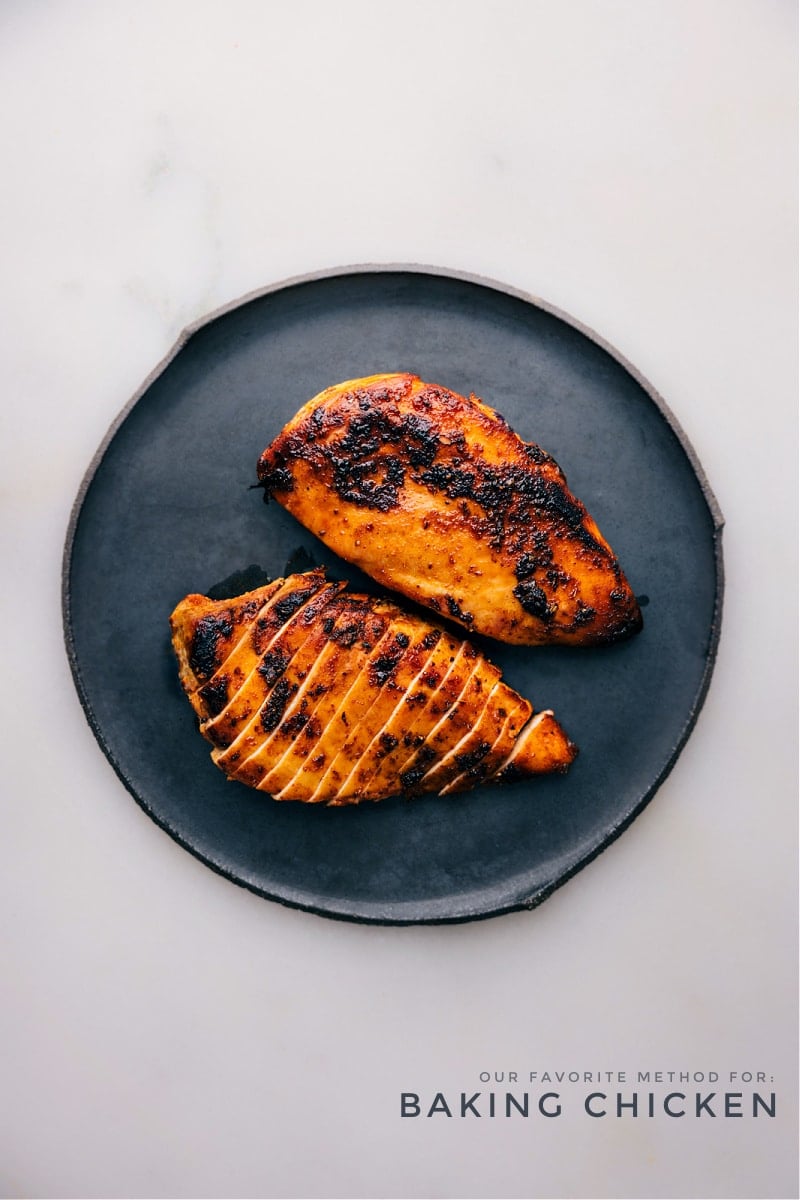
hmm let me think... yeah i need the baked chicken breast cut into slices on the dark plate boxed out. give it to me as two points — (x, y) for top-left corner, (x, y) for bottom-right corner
(170, 570), (576, 805)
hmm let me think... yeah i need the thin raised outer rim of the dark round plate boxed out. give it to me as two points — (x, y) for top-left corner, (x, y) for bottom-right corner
(61, 263), (724, 928)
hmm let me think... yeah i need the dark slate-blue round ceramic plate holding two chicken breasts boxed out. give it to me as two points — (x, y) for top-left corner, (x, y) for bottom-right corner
(64, 268), (722, 923)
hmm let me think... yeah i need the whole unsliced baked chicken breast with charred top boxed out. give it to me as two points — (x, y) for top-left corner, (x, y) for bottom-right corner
(258, 374), (642, 646)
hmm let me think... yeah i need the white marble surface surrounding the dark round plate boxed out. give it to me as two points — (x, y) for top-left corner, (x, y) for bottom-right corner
(0, 0), (796, 1198)
